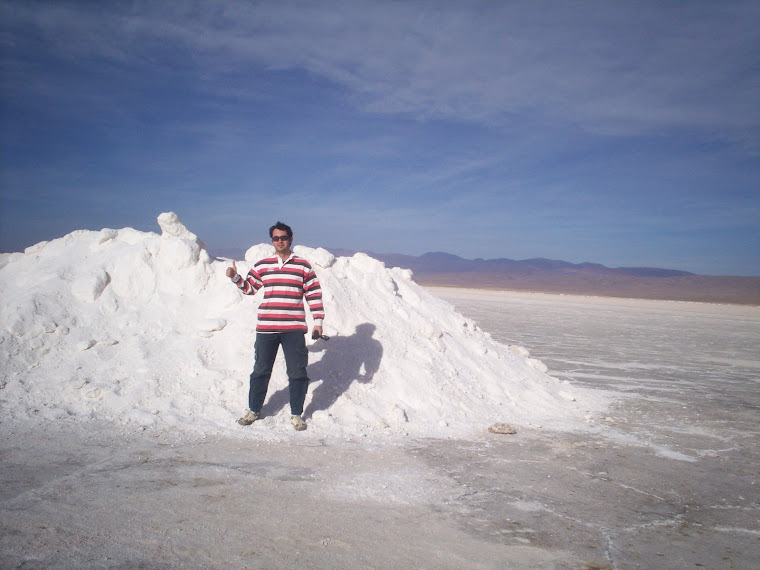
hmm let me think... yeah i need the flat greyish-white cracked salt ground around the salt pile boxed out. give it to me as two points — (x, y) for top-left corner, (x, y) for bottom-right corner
(0, 288), (760, 568)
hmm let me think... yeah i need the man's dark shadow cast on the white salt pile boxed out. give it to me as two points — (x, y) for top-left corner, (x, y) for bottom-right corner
(262, 323), (383, 418)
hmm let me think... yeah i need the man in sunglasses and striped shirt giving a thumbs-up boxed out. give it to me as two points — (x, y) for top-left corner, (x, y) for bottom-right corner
(226, 222), (325, 431)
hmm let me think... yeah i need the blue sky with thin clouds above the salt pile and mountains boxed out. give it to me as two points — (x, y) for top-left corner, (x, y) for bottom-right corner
(0, 0), (760, 275)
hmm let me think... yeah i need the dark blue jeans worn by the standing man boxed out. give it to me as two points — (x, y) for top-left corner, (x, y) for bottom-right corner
(248, 332), (309, 416)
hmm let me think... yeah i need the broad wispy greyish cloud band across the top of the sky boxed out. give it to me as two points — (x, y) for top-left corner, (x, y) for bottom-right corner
(4, 1), (760, 144)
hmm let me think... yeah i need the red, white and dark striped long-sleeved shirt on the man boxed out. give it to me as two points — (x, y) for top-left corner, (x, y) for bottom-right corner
(234, 255), (325, 333)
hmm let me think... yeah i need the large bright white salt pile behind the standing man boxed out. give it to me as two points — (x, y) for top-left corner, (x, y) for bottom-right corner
(0, 213), (607, 439)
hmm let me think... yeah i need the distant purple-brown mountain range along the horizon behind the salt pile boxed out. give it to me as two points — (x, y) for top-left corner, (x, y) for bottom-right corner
(211, 249), (760, 305)
